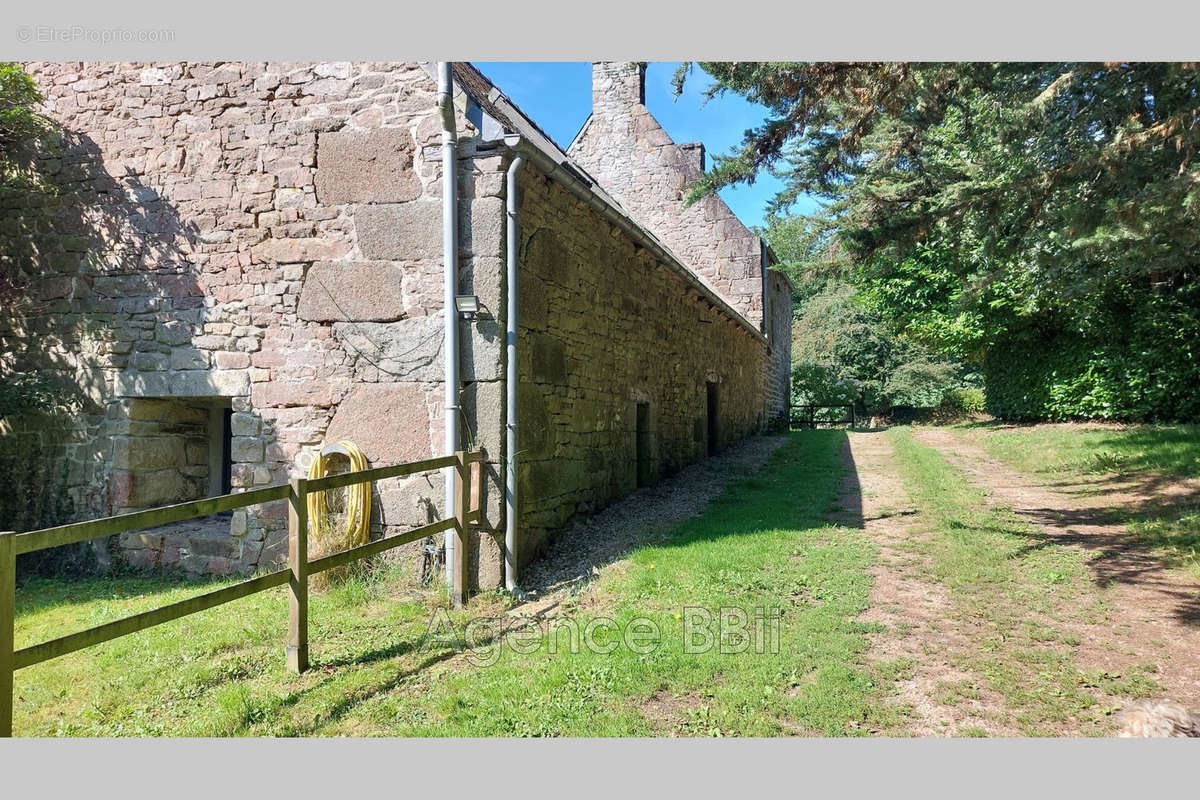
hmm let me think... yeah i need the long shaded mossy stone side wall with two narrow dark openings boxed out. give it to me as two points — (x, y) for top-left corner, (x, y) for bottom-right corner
(517, 167), (767, 561)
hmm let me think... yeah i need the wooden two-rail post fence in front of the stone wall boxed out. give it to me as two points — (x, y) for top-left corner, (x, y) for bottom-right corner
(0, 450), (486, 736)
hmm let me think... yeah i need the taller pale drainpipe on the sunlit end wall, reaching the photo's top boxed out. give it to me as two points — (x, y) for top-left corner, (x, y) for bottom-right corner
(438, 61), (458, 589)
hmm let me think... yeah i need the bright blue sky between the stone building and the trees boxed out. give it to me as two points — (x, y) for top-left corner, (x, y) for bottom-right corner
(473, 61), (816, 225)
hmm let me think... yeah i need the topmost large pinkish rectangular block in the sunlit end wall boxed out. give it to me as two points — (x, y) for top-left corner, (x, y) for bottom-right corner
(316, 128), (421, 205)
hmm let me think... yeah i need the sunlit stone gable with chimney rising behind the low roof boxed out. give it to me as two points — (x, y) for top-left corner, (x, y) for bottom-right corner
(569, 61), (763, 325)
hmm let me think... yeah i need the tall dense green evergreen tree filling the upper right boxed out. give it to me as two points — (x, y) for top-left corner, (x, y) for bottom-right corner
(677, 62), (1200, 417)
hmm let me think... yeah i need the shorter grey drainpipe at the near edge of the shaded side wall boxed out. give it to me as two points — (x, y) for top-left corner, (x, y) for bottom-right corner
(504, 155), (524, 593)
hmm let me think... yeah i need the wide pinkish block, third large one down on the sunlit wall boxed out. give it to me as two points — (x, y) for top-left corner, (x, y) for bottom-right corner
(298, 261), (404, 323)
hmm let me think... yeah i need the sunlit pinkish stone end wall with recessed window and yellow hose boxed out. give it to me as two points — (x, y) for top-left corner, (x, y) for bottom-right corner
(0, 57), (503, 585)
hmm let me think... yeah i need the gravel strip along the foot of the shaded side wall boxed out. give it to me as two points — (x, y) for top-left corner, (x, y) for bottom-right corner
(514, 435), (787, 604)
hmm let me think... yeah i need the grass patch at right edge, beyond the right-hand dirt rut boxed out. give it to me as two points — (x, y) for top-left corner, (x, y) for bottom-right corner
(962, 423), (1200, 579)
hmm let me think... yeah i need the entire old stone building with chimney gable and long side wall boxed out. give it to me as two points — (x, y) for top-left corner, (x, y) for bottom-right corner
(0, 62), (791, 587)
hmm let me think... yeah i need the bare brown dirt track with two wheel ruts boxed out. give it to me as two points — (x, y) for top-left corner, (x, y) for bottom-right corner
(836, 428), (1200, 735)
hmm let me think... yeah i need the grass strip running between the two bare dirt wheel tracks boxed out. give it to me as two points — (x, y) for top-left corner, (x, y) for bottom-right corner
(884, 428), (1156, 735)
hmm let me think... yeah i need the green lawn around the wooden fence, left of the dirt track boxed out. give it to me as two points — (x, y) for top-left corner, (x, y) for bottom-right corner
(14, 431), (898, 736)
